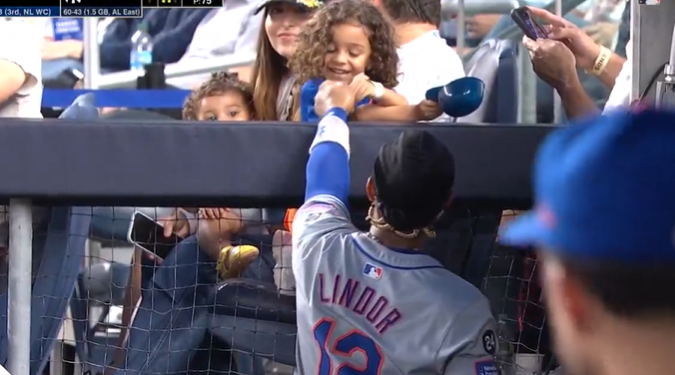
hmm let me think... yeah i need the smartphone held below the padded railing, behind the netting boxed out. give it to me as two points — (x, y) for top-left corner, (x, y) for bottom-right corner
(128, 211), (183, 259)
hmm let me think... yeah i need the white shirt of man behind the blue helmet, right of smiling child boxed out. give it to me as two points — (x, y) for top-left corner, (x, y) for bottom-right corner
(394, 31), (465, 105)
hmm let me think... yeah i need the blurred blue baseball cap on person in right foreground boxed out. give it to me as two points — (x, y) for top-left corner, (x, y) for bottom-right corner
(500, 109), (675, 264)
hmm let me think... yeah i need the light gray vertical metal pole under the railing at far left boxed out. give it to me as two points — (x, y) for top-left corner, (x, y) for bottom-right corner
(7, 198), (33, 375)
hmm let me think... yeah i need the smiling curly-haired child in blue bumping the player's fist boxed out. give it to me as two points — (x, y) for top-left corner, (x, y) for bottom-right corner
(291, 0), (408, 121)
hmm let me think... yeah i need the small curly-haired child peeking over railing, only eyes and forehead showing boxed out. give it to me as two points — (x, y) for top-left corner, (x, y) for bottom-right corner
(183, 72), (255, 121)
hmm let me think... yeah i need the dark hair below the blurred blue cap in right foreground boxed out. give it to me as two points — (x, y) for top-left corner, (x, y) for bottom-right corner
(559, 258), (675, 319)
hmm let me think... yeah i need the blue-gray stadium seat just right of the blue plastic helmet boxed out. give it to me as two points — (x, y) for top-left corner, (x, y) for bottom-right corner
(458, 39), (520, 124)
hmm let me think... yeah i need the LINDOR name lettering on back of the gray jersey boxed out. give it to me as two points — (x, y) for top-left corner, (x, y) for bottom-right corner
(319, 273), (402, 334)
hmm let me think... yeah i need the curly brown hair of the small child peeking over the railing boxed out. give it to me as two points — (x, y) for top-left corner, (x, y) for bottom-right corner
(183, 72), (255, 120)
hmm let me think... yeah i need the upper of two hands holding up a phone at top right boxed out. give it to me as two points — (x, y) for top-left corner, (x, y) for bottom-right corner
(527, 7), (601, 70)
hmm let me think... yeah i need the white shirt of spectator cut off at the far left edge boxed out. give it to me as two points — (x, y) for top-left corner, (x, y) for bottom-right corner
(0, 18), (45, 118)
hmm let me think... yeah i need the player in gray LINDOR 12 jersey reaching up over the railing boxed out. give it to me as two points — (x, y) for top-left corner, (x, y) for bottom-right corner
(293, 82), (497, 375)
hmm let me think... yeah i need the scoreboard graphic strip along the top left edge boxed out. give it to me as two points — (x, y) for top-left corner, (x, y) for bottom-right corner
(0, 0), (223, 18)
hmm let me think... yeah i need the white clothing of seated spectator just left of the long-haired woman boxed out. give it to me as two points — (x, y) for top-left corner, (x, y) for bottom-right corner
(167, 0), (264, 89)
